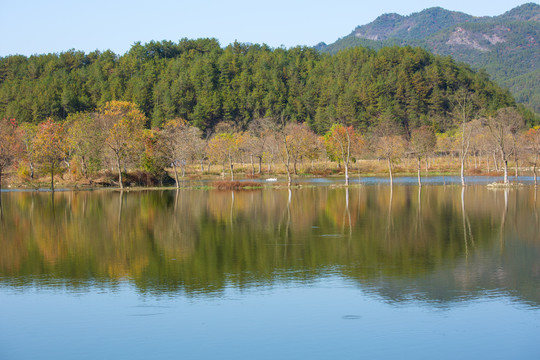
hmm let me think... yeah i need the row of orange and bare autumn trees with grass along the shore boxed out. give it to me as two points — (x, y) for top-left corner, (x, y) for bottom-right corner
(0, 102), (540, 189)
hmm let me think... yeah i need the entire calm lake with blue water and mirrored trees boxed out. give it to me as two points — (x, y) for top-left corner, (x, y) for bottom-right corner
(0, 178), (540, 360)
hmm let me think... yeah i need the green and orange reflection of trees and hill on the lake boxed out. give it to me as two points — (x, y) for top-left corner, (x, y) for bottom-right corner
(0, 186), (540, 303)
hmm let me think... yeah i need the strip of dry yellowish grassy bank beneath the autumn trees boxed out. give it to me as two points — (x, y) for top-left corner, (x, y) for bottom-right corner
(2, 157), (529, 190)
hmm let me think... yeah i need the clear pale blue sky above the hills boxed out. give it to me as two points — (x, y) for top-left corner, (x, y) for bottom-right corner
(0, 0), (530, 56)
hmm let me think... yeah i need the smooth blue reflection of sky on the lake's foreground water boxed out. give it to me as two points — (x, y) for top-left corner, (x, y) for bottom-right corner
(0, 276), (540, 360)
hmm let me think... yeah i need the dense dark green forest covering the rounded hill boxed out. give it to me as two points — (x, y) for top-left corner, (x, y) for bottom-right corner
(0, 39), (515, 133)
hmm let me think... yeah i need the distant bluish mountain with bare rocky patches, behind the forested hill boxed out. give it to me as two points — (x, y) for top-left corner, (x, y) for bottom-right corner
(315, 3), (540, 113)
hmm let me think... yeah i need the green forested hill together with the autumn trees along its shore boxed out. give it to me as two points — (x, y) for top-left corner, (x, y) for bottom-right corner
(0, 39), (538, 188)
